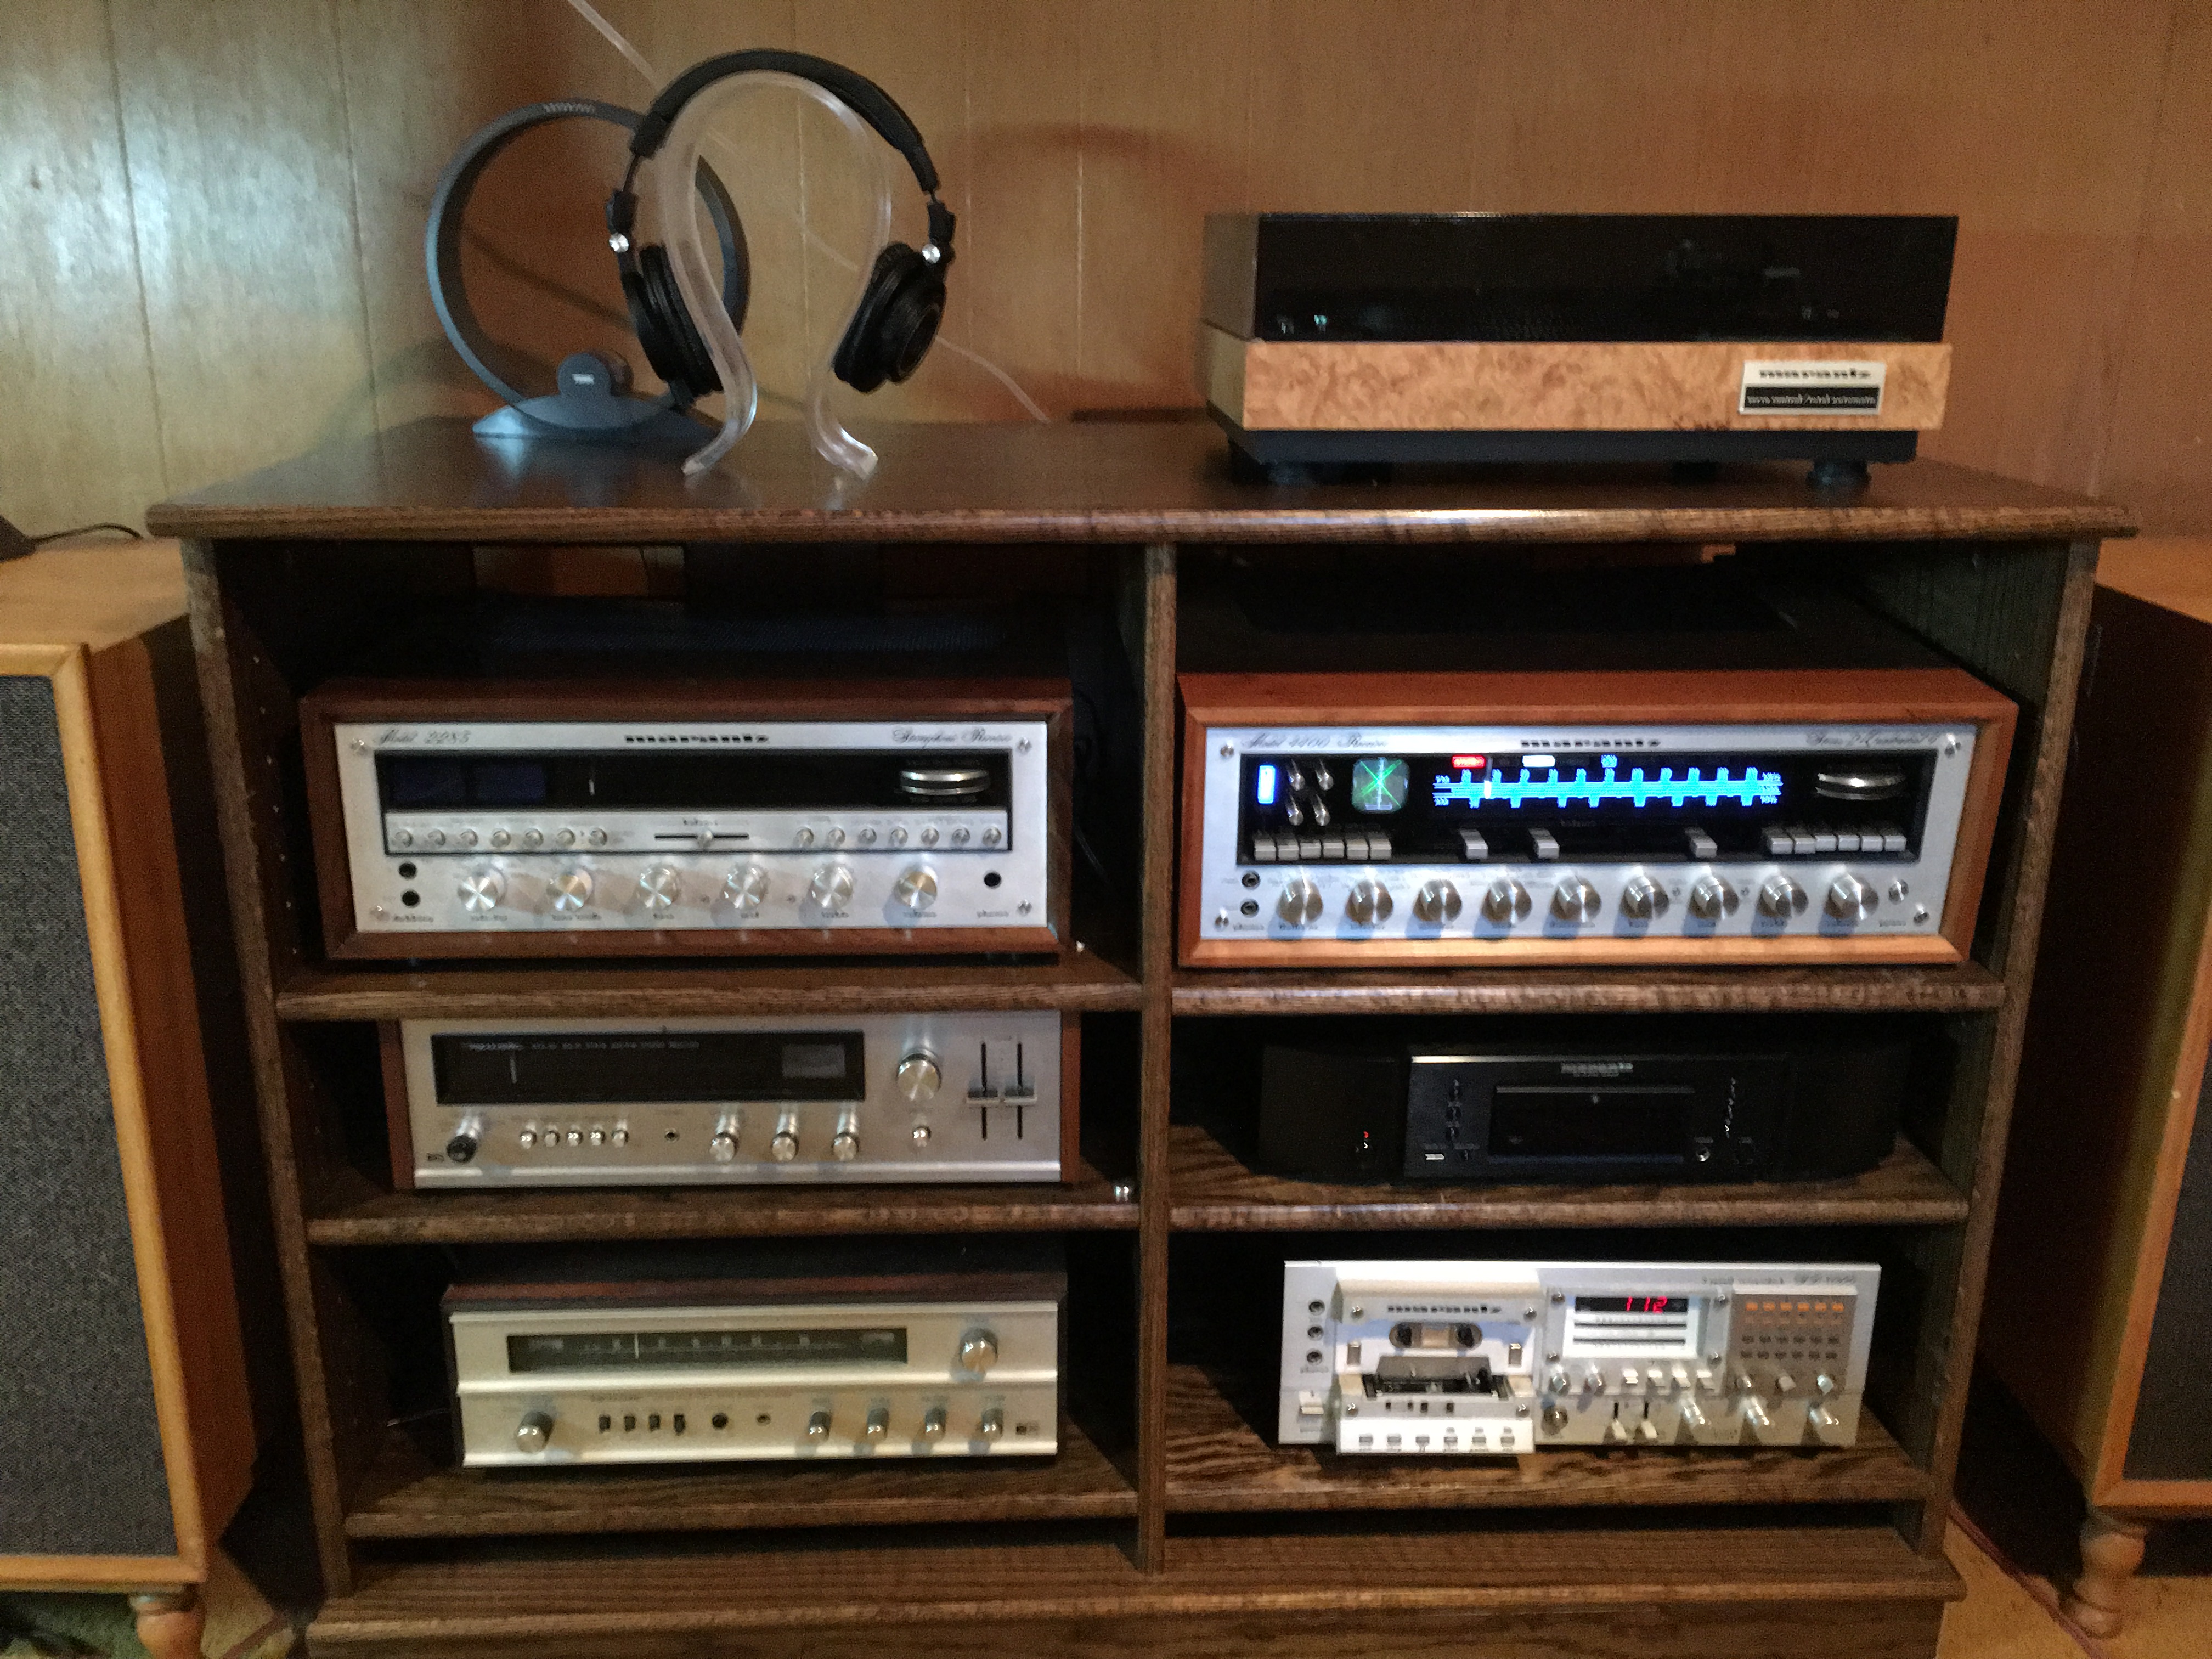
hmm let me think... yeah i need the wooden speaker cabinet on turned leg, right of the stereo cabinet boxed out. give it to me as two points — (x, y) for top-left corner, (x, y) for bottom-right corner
(1982, 540), (2212, 1635)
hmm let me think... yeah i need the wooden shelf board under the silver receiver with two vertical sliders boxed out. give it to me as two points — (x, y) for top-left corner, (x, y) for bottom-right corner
(307, 1164), (1137, 1245)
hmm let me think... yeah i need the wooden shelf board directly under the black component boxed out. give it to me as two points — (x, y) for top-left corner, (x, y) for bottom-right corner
(1168, 1124), (1966, 1232)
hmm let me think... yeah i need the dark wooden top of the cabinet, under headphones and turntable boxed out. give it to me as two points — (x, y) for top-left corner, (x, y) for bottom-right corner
(148, 420), (2132, 544)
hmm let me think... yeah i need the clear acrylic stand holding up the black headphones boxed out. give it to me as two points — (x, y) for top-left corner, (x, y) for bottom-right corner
(641, 71), (891, 478)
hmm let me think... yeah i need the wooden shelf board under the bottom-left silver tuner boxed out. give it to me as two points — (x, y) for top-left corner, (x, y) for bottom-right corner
(345, 1418), (1137, 1537)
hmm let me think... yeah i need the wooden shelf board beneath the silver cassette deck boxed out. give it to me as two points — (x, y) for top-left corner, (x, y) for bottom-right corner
(1168, 1365), (1927, 1513)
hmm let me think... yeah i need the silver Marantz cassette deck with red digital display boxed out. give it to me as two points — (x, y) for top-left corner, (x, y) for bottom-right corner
(1278, 1261), (1882, 1458)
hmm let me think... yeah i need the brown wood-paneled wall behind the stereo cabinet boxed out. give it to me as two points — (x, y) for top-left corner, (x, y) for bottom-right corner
(0, 0), (2212, 531)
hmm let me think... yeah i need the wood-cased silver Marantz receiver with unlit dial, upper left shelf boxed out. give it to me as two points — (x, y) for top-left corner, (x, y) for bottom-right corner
(301, 679), (1070, 956)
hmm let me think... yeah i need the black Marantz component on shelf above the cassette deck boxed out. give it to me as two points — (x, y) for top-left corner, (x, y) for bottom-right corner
(1259, 1015), (1914, 1183)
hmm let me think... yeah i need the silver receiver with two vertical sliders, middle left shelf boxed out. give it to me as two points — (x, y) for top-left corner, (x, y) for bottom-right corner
(385, 1011), (1080, 1188)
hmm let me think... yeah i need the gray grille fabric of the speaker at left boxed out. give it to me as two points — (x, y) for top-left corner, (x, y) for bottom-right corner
(0, 675), (177, 1555)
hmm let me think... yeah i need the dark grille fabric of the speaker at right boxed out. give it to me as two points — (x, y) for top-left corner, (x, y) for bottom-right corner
(2126, 1053), (2212, 1480)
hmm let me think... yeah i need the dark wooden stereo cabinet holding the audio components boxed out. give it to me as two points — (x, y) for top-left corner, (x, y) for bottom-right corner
(150, 422), (2128, 1659)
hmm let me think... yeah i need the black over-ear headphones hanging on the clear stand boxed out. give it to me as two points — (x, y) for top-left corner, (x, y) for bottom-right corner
(606, 51), (953, 409)
